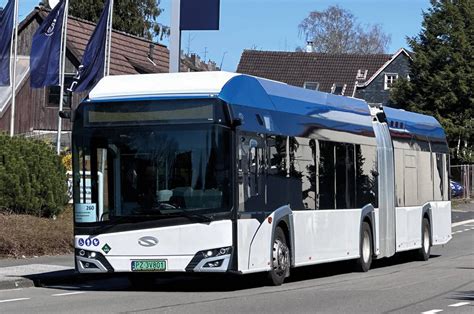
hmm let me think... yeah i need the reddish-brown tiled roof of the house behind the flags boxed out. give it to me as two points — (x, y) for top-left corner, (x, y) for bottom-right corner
(26, 7), (169, 75)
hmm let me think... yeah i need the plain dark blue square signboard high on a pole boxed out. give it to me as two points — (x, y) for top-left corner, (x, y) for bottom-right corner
(180, 0), (220, 31)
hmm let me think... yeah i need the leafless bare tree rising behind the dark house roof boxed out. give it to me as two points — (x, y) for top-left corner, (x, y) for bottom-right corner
(298, 6), (390, 54)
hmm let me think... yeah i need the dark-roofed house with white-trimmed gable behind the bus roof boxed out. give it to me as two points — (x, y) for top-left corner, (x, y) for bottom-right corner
(237, 48), (411, 106)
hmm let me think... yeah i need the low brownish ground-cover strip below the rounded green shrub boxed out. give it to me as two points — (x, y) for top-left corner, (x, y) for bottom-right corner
(0, 206), (74, 258)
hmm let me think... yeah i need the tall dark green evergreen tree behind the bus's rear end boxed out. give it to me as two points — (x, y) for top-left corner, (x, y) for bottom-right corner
(391, 0), (474, 163)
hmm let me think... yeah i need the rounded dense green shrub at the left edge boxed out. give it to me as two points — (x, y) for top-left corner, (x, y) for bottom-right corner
(0, 134), (67, 217)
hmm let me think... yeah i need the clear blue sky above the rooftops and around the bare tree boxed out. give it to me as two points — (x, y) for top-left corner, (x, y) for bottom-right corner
(14, 0), (430, 71)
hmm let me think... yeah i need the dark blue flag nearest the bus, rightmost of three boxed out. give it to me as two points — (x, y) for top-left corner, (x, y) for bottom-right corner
(69, 0), (112, 92)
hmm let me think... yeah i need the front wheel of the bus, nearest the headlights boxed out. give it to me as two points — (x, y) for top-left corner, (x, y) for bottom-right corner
(268, 227), (290, 286)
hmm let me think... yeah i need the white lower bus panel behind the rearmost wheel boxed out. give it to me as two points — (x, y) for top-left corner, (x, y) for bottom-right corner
(430, 201), (452, 245)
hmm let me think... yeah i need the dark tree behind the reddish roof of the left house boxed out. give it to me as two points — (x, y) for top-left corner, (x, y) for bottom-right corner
(44, 0), (169, 39)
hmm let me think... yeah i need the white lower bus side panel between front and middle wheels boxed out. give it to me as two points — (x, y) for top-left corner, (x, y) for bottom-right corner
(293, 209), (361, 266)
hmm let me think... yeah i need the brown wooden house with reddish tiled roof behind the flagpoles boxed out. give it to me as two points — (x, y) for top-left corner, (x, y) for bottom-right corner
(0, 8), (169, 145)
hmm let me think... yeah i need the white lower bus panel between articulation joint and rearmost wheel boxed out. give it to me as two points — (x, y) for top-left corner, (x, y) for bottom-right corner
(396, 206), (422, 252)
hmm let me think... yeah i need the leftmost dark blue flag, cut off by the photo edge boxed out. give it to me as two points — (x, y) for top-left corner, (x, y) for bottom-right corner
(0, 0), (15, 86)
